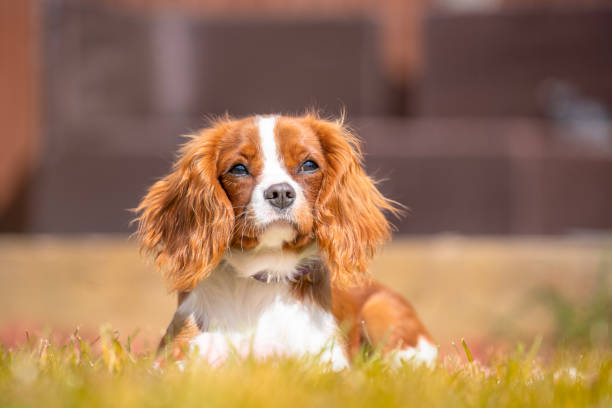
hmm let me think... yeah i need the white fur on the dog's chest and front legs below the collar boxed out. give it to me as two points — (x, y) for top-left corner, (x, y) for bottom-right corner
(178, 263), (348, 370)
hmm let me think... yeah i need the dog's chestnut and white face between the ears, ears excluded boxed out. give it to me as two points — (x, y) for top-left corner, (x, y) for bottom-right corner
(217, 117), (327, 250)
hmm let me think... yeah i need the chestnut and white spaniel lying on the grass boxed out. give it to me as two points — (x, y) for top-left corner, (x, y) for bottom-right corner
(136, 115), (437, 370)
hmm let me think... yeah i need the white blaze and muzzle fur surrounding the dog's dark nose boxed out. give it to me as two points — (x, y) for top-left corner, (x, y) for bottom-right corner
(249, 116), (305, 227)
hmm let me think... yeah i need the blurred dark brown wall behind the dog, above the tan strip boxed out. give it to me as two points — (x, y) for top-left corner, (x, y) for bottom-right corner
(0, 0), (612, 234)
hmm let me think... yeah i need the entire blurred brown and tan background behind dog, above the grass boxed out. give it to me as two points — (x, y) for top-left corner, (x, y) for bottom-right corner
(0, 0), (612, 356)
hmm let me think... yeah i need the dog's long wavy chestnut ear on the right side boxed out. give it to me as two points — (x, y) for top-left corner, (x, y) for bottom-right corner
(307, 116), (399, 285)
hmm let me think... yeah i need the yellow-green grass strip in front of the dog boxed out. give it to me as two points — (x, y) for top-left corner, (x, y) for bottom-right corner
(0, 329), (612, 408)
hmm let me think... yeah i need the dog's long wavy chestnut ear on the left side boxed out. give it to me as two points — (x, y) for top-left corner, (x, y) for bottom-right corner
(135, 124), (234, 292)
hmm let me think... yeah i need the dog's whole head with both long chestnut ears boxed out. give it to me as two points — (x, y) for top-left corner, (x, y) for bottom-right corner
(136, 115), (395, 291)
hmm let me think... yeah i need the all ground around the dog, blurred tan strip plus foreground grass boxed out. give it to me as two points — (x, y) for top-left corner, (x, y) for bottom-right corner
(0, 236), (612, 408)
